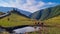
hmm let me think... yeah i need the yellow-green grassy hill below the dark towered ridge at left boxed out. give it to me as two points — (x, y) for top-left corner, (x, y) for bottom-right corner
(0, 13), (32, 26)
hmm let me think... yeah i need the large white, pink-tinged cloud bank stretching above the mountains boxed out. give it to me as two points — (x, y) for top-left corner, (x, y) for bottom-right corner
(0, 0), (56, 13)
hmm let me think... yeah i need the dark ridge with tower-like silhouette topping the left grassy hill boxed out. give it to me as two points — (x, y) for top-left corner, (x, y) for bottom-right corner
(0, 8), (30, 19)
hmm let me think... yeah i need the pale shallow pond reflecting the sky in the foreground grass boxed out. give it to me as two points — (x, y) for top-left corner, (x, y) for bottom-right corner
(13, 26), (39, 33)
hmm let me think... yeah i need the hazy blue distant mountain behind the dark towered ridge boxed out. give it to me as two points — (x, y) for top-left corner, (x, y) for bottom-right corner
(0, 7), (31, 17)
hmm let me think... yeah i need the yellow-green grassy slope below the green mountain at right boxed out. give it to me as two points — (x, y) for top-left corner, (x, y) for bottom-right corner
(44, 15), (60, 25)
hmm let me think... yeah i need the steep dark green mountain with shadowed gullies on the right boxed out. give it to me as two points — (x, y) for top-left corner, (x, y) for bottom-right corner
(30, 5), (60, 20)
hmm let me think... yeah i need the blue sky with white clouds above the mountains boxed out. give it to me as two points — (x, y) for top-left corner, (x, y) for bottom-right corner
(0, 0), (60, 13)
